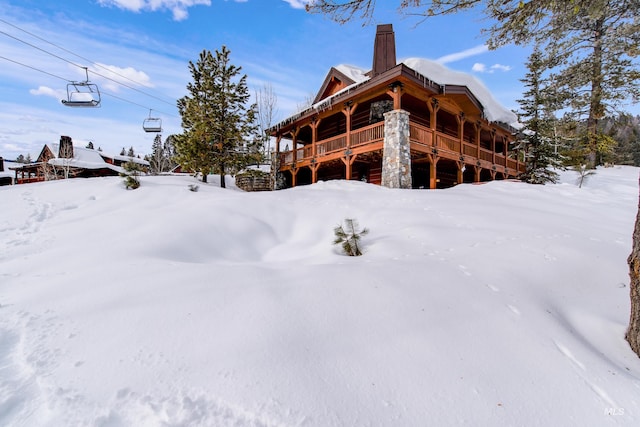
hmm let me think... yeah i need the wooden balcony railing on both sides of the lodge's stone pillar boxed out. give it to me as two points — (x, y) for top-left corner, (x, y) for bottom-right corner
(280, 122), (524, 172)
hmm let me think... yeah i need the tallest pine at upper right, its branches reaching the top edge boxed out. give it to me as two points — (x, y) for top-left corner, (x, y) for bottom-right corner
(485, 0), (640, 167)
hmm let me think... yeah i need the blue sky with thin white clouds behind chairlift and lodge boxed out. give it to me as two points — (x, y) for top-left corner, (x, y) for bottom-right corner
(0, 0), (552, 159)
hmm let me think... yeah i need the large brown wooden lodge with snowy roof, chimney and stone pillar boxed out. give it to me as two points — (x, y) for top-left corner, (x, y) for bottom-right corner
(269, 24), (524, 189)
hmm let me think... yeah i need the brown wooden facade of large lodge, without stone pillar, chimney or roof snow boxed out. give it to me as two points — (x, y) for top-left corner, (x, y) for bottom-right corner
(272, 64), (524, 189)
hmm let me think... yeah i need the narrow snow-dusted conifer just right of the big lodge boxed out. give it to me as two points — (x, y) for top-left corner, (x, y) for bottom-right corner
(518, 47), (559, 184)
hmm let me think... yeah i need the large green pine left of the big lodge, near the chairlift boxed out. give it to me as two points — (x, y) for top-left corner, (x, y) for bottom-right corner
(174, 46), (261, 187)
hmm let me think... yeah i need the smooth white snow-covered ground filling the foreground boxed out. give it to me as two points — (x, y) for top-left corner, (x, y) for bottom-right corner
(0, 167), (640, 427)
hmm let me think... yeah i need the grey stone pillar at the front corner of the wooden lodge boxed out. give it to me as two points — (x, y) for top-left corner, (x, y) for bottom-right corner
(382, 110), (411, 188)
